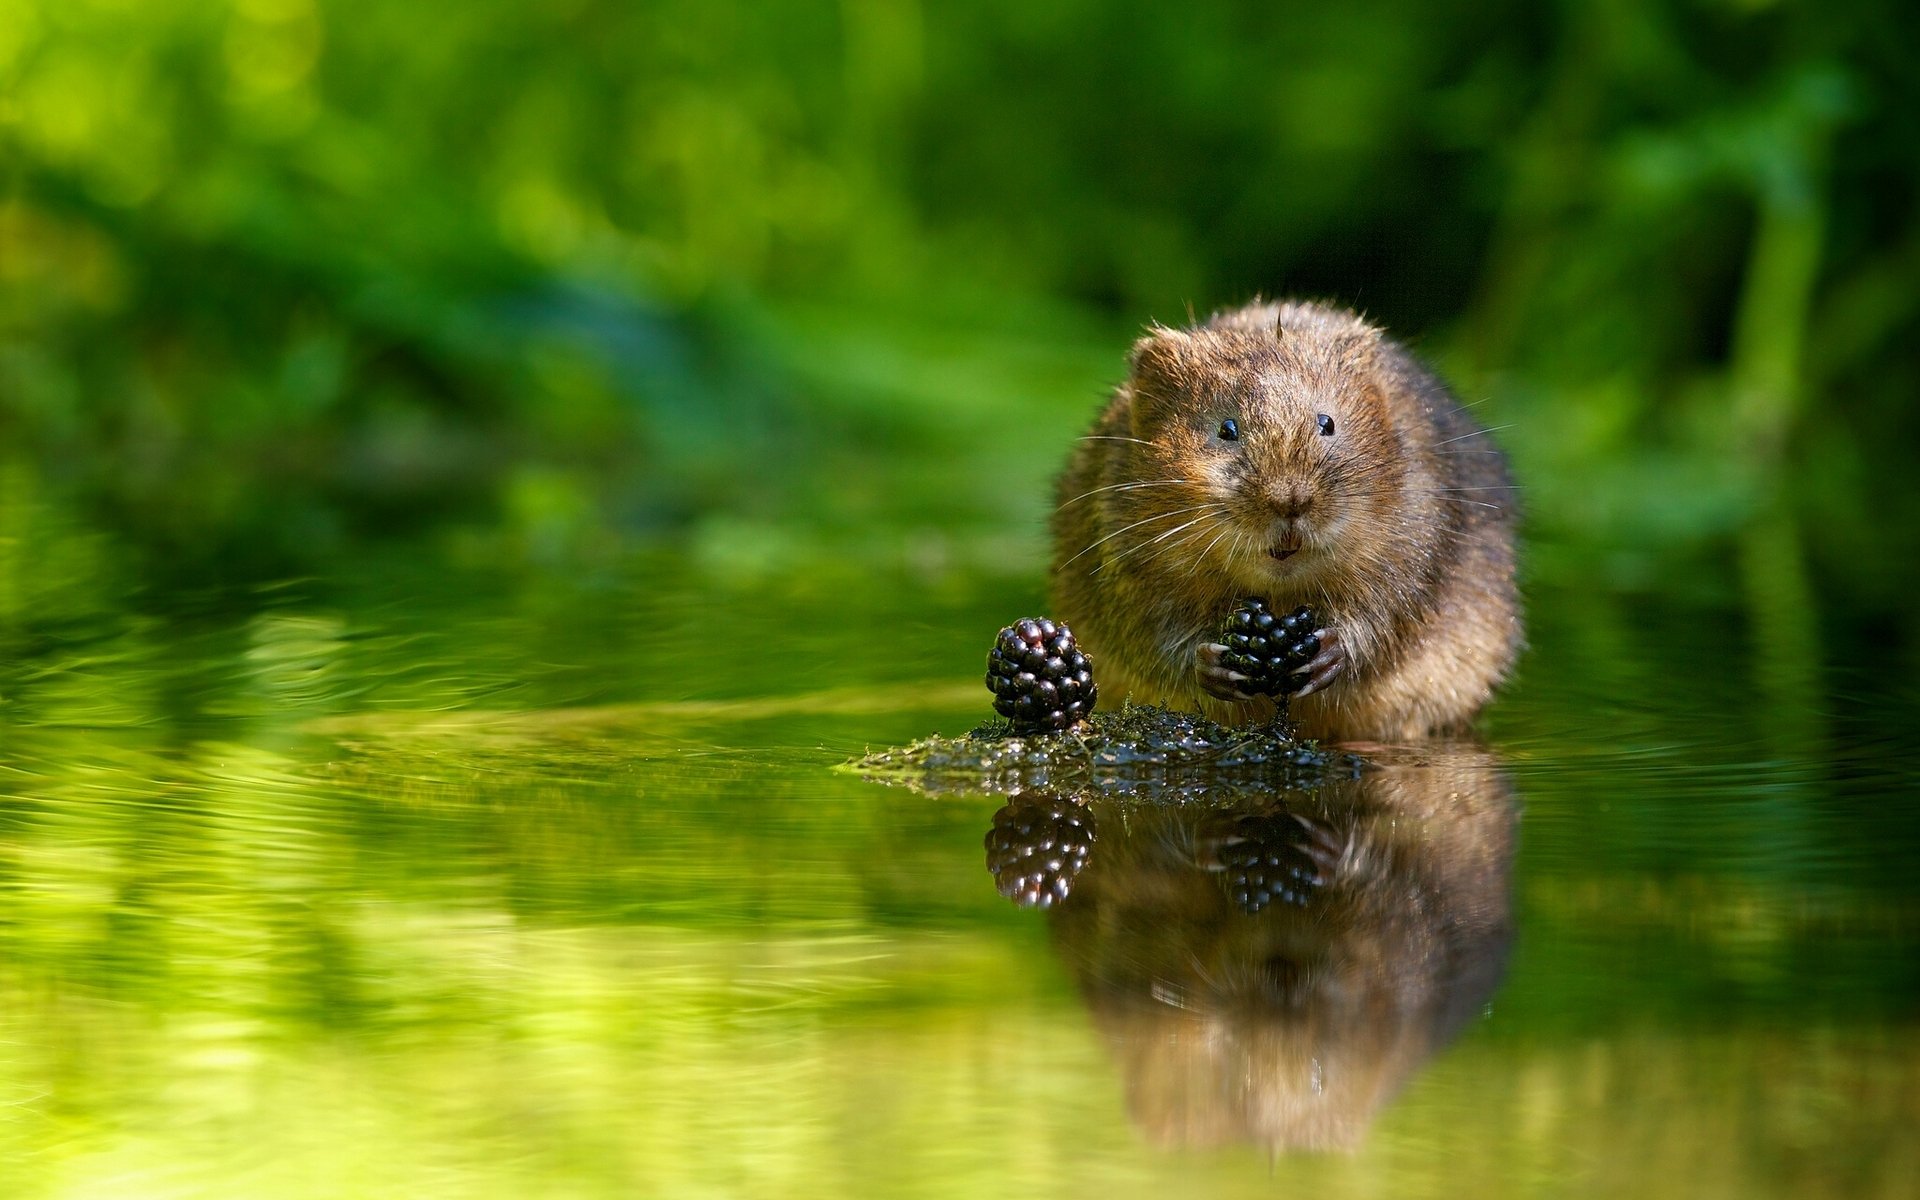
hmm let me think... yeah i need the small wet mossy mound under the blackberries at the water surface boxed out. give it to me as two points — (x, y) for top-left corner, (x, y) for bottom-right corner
(849, 705), (1359, 801)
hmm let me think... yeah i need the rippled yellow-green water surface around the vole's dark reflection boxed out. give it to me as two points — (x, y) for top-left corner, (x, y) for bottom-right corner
(0, 557), (1920, 1198)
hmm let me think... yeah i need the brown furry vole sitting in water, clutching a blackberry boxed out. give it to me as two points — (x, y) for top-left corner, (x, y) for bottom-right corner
(1052, 303), (1521, 739)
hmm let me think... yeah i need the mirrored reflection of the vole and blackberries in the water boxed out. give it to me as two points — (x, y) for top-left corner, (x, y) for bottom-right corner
(987, 743), (1519, 1150)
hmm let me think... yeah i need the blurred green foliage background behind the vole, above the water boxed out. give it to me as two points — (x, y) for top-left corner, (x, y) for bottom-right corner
(0, 0), (1920, 656)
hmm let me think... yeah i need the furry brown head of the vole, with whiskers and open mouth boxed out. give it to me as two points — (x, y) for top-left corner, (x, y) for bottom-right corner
(1129, 305), (1405, 595)
